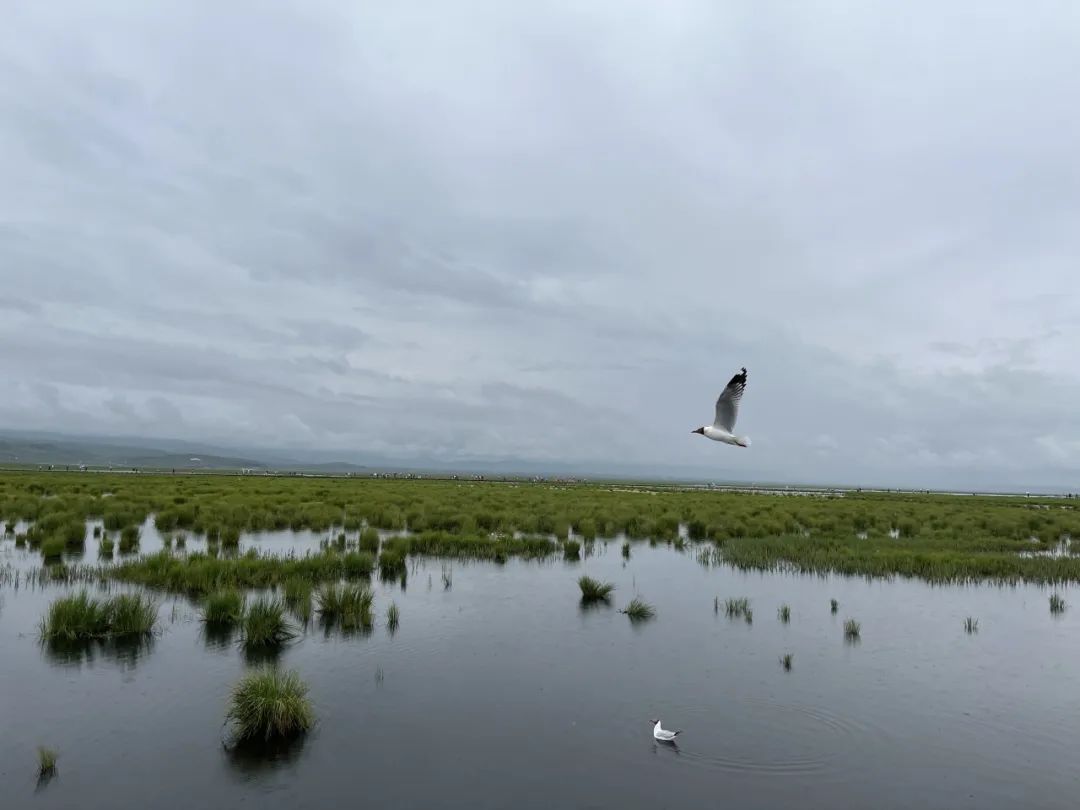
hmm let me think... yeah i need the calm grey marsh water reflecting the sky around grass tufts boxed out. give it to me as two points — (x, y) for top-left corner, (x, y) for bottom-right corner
(0, 523), (1080, 810)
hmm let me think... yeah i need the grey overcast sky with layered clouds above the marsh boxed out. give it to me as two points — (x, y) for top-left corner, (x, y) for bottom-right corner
(0, 0), (1080, 487)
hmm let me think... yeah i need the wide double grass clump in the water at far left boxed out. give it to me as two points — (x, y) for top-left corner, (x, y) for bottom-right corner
(40, 591), (158, 642)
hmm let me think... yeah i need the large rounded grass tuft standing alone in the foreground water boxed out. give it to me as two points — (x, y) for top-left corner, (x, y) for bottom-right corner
(226, 669), (315, 741)
